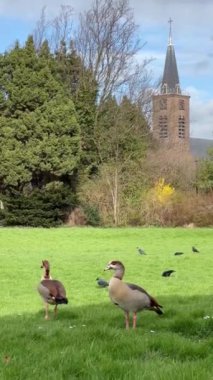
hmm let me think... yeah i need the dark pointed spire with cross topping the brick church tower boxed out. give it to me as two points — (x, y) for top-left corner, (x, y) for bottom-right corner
(161, 18), (181, 94)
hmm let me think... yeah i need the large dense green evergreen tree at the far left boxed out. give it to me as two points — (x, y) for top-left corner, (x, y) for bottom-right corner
(0, 37), (81, 225)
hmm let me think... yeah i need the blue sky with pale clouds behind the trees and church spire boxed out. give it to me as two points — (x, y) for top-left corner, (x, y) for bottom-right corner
(0, 0), (213, 139)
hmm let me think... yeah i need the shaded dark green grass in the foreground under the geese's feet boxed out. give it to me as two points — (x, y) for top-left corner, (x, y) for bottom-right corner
(0, 295), (213, 380)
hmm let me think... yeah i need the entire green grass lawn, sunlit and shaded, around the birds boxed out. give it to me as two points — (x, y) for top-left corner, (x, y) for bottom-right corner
(0, 228), (213, 380)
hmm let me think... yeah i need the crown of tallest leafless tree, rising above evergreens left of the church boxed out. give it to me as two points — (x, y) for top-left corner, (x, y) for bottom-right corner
(76, 0), (146, 102)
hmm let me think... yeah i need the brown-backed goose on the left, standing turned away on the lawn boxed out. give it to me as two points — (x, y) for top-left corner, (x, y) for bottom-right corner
(38, 260), (68, 319)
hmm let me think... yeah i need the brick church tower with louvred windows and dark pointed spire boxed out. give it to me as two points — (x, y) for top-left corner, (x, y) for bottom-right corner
(152, 19), (190, 151)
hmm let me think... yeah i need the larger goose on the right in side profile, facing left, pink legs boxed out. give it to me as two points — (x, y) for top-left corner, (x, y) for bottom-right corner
(105, 260), (163, 329)
